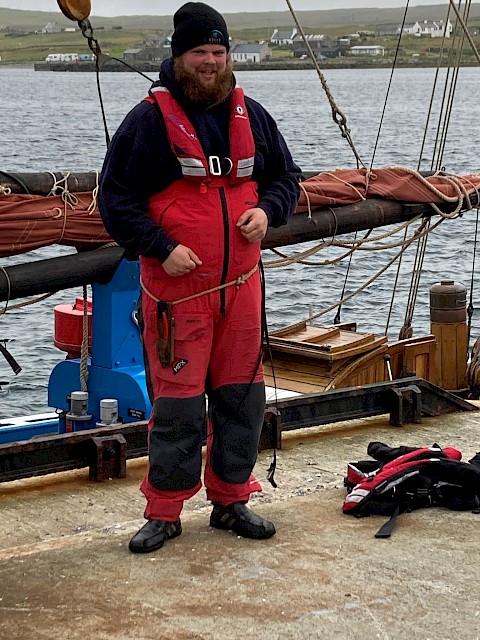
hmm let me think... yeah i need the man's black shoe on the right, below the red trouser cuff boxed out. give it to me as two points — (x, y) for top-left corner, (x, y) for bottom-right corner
(210, 502), (275, 540)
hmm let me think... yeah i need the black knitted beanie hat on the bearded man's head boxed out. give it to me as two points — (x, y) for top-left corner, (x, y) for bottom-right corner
(172, 2), (230, 58)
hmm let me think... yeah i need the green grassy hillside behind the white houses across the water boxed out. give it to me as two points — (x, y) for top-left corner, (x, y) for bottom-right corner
(0, 3), (480, 64)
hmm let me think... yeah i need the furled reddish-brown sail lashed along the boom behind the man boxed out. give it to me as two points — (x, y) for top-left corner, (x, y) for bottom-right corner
(0, 167), (480, 257)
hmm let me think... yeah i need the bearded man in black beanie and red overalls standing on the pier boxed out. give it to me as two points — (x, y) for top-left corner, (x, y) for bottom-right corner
(99, 2), (300, 553)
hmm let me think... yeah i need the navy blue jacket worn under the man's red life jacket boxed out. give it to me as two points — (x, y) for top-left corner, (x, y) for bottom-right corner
(99, 58), (301, 262)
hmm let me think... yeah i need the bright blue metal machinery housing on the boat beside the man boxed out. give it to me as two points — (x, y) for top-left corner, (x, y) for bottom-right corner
(0, 260), (151, 444)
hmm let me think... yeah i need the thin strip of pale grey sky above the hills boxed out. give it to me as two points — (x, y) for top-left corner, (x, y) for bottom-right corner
(0, 0), (456, 16)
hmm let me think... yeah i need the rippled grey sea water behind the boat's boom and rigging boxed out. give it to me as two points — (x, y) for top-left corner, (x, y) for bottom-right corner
(0, 68), (480, 418)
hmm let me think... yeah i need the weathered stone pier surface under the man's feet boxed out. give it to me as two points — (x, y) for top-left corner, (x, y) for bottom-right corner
(0, 412), (480, 640)
